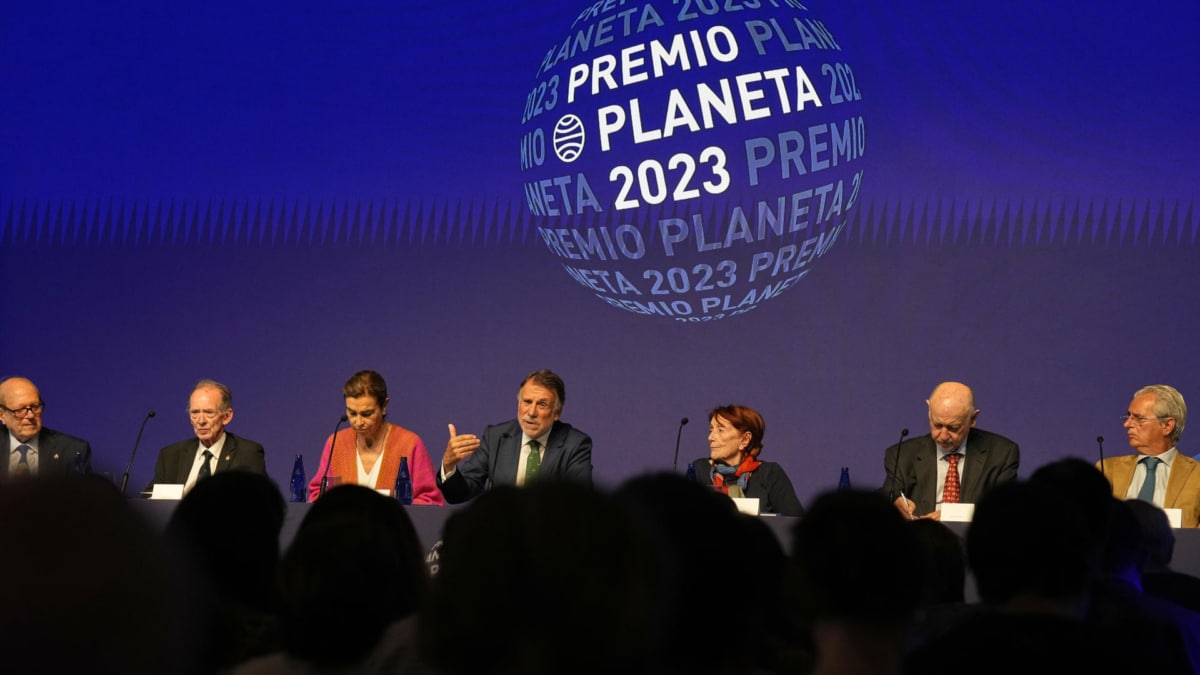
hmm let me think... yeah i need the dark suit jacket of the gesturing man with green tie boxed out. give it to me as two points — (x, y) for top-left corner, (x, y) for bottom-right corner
(437, 419), (592, 504)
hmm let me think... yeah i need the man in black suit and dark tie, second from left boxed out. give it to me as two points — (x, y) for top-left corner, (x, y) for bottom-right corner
(148, 380), (266, 492)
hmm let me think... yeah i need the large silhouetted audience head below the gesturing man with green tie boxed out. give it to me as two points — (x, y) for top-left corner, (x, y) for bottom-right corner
(421, 483), (654, 675)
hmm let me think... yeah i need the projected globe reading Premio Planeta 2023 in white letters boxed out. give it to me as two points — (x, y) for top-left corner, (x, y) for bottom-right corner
(520, 0), (866, 323)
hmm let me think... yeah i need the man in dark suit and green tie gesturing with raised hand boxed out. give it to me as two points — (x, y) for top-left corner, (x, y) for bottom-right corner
(437, 370), (592, 503)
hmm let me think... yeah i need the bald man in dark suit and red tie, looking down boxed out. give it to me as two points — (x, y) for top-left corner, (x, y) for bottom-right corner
(880, 382), (1021, 520)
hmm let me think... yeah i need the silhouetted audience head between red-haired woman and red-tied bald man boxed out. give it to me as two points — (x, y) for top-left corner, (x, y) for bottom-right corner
(792, 491), (922, 627)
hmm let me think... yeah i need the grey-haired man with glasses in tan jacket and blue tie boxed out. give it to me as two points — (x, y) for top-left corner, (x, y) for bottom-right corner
(1097, 384), (1200, 527)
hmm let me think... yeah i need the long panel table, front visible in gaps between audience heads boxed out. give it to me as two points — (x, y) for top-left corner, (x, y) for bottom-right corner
(130, 500), (1200, 577)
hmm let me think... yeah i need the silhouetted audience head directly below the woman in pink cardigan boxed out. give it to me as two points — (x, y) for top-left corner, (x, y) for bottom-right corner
(278, 485), (428, 668)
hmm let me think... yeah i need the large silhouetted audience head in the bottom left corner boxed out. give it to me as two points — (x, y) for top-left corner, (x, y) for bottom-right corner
(0, 477), (205, 675)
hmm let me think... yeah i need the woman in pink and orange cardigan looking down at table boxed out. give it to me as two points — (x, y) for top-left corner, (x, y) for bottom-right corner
(308, 370), (445, 506)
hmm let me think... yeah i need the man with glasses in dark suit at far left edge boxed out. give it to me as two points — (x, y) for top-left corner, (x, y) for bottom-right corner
(0, 377), (91, 479)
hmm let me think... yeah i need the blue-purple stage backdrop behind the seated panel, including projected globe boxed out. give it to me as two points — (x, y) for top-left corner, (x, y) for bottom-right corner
(0, 0), (1200, 501)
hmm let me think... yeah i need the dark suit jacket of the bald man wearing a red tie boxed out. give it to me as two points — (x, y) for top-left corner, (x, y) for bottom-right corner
(880, 428), (1021, 515)
